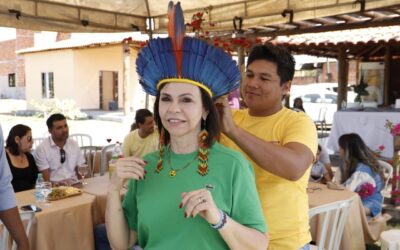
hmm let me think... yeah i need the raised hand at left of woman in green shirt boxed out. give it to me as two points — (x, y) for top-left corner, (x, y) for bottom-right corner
(110, 157), (147, 191)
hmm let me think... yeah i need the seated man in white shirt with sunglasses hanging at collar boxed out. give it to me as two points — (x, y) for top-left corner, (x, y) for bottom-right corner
(34, 114), (85, 185)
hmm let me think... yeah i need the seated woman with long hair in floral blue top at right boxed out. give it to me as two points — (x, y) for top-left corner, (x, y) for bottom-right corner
(339, 133), (384, 217)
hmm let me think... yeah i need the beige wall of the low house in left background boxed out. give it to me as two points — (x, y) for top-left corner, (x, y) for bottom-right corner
(25, 45), (144, 110)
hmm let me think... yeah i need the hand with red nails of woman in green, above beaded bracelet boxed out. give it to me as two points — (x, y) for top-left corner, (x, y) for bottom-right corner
(179, 189), (220, 224)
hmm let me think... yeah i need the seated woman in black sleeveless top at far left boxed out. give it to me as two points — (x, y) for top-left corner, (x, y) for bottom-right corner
(6, 124), (39, 192)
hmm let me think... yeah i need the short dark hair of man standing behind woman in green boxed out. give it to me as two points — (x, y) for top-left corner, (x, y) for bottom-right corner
(247, 44), (296, 85)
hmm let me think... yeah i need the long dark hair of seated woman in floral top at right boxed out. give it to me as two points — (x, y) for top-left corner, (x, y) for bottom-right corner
(339, 133), (383, 182)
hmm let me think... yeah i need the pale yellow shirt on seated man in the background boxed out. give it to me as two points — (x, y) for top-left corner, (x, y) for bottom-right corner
(123, 129), (158, 157)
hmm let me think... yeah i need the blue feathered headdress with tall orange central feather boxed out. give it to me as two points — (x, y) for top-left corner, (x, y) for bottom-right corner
(136, 1), (240, 98)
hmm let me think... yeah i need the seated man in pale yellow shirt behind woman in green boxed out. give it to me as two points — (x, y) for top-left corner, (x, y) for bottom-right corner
(123, 109), (159, 157)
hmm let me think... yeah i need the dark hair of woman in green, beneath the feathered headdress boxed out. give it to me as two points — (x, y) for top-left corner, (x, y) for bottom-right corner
(154, 84), (220, 147)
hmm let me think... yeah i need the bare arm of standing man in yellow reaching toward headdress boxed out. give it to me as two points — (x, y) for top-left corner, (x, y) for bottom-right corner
(218, 99), (314, 181)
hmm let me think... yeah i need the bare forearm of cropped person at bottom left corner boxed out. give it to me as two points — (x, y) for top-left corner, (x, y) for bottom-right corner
(0, 207), (29, 250)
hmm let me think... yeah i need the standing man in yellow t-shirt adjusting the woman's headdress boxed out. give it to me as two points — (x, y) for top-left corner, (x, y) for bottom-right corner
(217, 45), (318, 250)
